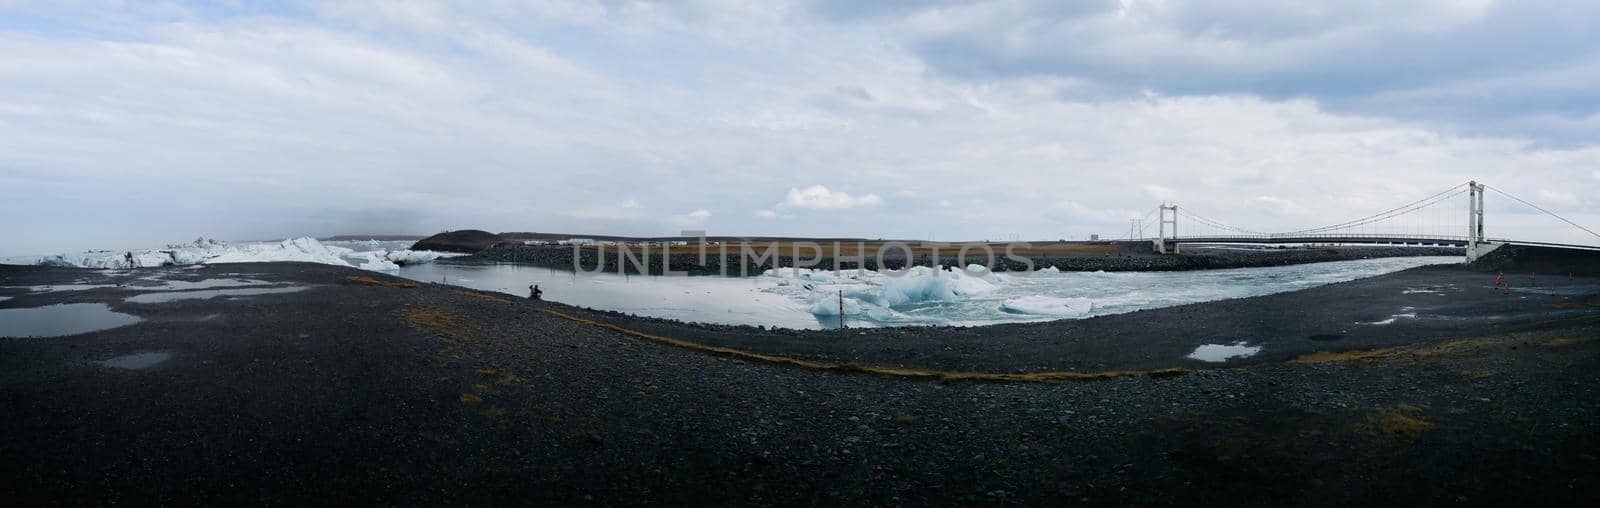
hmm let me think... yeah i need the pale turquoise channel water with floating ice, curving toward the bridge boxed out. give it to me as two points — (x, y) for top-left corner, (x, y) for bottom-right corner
(398, 257), (1461, 329)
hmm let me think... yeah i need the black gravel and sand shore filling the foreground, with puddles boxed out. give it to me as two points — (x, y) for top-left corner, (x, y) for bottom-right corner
(0, 264), (1600, 506)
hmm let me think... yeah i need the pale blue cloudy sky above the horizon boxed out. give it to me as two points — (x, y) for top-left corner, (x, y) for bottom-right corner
(0, 0), (1600, 256)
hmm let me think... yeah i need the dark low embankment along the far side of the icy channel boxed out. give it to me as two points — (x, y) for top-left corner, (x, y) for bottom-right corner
(451, 243), (1462, 276)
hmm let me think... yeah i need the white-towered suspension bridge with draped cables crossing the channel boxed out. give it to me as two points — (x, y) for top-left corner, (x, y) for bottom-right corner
(1128, 182), (1600, 262)
